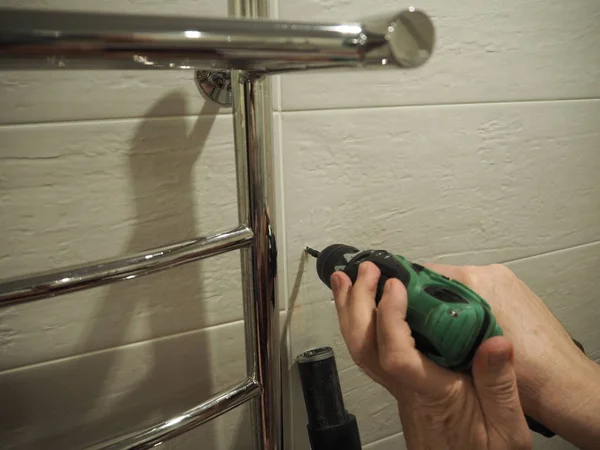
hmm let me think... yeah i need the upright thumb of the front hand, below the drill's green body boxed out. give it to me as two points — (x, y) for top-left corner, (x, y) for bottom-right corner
(473, 336), (528, 440)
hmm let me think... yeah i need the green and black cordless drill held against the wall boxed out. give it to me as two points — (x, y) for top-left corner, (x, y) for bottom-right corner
(305, 244), (583, 437)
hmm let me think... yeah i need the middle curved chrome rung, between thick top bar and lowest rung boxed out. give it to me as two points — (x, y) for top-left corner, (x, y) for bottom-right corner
(0, 225), (254, 307)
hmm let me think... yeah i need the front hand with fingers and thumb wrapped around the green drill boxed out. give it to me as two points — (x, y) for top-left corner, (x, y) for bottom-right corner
(331, 262), (531, 450)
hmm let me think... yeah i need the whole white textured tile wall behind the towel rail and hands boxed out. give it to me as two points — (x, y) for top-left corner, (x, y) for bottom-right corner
(0, 0), (600, 450)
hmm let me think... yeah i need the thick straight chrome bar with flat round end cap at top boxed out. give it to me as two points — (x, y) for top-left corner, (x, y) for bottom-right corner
(0, 8), (435, 73)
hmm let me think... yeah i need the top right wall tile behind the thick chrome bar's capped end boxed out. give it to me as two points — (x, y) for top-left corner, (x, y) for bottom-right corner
(279, 0), (600, 110)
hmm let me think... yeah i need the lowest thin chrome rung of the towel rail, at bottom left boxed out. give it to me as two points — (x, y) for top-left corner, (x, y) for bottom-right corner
(88, 378), (261, 450)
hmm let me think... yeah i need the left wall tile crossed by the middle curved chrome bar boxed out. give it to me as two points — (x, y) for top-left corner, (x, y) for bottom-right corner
(0, 107), (248, 368)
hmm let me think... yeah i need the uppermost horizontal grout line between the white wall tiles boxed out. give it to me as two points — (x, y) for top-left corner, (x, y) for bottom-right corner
(0, 95), (600, 130)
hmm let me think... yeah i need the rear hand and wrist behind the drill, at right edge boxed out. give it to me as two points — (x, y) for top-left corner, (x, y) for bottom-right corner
(425, 264), (600, 448)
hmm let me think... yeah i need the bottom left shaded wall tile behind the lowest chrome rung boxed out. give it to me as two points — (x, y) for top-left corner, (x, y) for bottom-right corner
(0, 322), (251, 450)
